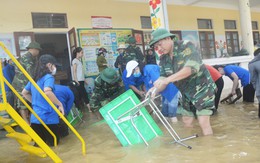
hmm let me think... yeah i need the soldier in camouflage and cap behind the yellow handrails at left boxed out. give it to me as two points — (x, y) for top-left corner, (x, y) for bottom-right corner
(12, 41), (42, 124)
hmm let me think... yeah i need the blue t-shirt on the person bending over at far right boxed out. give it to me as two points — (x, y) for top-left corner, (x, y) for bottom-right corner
(224, 65), (250, 87)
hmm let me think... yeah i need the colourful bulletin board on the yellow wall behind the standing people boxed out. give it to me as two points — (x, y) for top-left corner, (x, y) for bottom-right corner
(77, 28), (132, 77)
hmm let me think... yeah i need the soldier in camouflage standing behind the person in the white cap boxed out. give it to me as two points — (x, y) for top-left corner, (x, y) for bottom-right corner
(123, 37), (144, 65)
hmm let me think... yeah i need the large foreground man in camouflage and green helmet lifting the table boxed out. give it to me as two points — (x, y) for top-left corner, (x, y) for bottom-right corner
(148, 29), (216, 135)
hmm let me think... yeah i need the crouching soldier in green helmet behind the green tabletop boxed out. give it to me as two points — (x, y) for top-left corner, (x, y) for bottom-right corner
(90, 68), (124, 118)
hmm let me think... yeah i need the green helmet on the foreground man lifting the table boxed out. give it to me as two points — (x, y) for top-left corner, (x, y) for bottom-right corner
(149, 28), (175, 46)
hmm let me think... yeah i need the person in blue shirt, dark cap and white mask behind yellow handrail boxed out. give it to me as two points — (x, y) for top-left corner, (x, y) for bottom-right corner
(22, 54), (64, 146)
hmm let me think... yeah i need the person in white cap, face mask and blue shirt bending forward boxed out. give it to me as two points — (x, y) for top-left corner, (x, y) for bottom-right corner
(122, 60), (145, 99)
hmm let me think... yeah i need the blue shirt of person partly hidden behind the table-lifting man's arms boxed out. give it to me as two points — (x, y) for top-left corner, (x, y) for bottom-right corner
(143, 64), (179, 101)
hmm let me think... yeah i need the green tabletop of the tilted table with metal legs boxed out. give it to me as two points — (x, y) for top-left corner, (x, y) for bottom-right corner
(99, 90), (163, 146)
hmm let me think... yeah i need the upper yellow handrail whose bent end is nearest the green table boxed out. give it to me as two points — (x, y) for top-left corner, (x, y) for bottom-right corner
(0, 42), (86, 155)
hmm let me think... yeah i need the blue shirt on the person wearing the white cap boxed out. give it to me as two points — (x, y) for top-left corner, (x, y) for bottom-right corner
(122, 70), (144, 91)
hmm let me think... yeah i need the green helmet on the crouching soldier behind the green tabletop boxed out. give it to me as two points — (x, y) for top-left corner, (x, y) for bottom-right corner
(100, 68), (119, 84)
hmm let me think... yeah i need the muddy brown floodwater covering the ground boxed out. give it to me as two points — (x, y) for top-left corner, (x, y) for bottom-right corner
(0, 102), (260, 163)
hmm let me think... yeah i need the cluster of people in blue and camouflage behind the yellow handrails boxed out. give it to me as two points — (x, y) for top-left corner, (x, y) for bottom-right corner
(3, 42), (74, 146)
